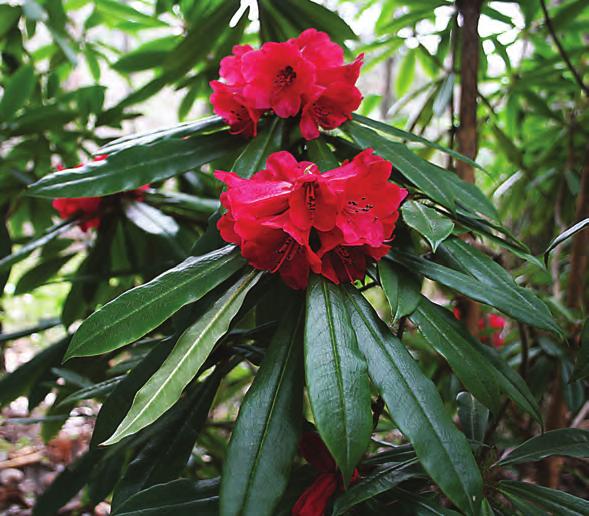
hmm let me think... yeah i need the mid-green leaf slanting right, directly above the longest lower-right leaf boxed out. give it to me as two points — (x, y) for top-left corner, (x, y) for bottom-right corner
(411, 296), (501, 413)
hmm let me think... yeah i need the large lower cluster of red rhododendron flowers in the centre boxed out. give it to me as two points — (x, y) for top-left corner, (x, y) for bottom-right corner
(215, 149), (407, 289)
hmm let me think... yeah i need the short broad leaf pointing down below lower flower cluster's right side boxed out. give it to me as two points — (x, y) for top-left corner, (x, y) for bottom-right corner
(378, 260), (421, 323)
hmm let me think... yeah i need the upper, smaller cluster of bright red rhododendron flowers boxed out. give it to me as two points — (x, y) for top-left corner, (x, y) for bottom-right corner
(211, 29), (364, 140)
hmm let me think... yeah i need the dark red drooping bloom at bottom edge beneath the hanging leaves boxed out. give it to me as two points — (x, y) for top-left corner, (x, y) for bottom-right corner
(291, 432), (360, 516)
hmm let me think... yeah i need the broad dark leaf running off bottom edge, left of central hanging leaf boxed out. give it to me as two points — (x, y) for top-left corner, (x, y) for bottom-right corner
(220, 294), (303, 516)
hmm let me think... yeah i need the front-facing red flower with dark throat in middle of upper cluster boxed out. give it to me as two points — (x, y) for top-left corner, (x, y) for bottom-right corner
(242, 42), (315, 118)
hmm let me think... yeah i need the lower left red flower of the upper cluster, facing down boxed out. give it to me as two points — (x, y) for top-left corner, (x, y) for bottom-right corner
(210, 81), (262, 137)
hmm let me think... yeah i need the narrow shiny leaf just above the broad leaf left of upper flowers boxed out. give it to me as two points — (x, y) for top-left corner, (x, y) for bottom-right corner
(94, 116), (224, 155)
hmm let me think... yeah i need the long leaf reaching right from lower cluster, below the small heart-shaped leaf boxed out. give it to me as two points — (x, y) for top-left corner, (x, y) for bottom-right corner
(389, 250), (562, 335)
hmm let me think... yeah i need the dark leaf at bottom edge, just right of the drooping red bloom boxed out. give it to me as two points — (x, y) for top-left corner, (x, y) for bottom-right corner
(332, 459), (418, 516)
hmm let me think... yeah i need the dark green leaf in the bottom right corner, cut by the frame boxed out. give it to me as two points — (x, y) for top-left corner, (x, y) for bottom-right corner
(497, 480), (589, 516)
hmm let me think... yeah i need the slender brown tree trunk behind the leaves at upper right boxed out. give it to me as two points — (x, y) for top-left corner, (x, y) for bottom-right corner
(456, 0), (483, 336)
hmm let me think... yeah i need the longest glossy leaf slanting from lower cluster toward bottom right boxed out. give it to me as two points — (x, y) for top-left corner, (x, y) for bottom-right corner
(346, 288), (482, 514)
